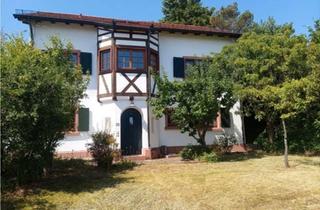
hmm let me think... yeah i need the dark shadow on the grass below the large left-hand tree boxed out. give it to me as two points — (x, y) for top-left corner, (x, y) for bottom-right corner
(1, 159), (137, 209)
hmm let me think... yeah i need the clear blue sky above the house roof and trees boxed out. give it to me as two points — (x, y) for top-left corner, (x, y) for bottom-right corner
(1, 0), (320, 35)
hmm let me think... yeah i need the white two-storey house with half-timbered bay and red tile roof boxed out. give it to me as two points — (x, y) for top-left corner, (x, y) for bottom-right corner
(14, 11), (244, 158)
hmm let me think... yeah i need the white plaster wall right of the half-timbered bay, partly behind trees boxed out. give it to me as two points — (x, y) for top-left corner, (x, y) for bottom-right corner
(157, 33), (243, 146)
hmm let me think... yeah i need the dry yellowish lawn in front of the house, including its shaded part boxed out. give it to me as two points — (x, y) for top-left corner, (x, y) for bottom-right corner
(2, 154), (320, 210)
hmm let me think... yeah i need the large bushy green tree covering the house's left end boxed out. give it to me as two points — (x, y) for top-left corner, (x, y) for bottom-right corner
(1, 37), (87, 183)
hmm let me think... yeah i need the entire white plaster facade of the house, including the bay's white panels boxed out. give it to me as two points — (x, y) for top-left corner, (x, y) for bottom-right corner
(32, 22), (243, 156)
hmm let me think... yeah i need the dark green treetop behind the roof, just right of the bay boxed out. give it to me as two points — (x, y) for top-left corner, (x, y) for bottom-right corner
(161, 0), (214, 26)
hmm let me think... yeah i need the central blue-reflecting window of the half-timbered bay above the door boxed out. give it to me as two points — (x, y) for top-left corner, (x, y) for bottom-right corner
(118, 49), (145, 69)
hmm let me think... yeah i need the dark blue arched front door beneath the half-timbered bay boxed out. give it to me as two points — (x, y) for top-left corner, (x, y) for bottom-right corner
(121, 108), (142, 155)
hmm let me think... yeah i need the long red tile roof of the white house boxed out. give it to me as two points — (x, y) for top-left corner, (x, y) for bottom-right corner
(13, 11), (241, 38)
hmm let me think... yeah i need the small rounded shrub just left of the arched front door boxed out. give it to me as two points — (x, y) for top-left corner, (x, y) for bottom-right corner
(88, 131), (119, 169)
